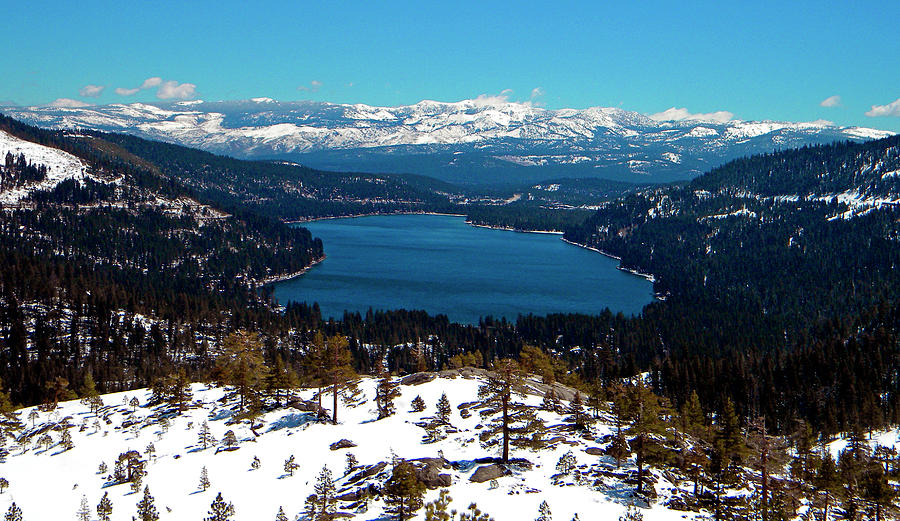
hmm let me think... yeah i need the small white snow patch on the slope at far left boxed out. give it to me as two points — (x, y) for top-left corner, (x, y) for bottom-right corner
(0, 130), (87, 206)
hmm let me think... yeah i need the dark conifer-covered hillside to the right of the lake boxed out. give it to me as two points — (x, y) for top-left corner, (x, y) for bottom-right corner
(566, 136), (900, 431)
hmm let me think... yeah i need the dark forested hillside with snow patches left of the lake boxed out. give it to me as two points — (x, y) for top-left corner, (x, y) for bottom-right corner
(0, 120), (323, 403)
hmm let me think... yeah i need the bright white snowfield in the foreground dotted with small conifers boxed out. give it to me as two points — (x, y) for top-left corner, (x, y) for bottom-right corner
(0, 377), (699, 521)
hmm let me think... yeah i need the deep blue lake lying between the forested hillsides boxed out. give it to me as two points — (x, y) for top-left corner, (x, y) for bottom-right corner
(274, 215), (653, 323)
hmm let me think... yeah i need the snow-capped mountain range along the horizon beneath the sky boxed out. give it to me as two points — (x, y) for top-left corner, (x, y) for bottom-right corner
(2, 97), (891, 183)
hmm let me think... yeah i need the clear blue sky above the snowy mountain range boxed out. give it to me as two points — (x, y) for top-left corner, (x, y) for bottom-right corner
(0, 0), (900, 132)
